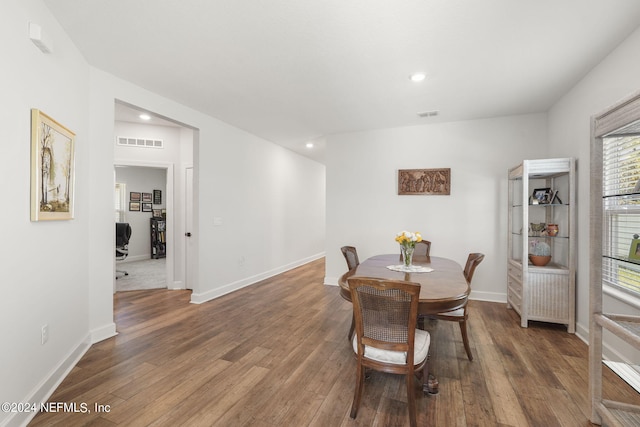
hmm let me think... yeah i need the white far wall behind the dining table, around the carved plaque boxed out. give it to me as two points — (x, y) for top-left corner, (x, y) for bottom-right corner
(325, 114), (547, 301)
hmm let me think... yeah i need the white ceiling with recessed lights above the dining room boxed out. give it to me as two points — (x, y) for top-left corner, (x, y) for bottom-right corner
(44, 0), (640, 161)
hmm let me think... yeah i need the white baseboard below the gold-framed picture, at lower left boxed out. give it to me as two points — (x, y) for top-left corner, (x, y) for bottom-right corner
(1, 334), (91, 426)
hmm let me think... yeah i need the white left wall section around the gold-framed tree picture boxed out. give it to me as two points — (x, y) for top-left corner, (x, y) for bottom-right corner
(0, 0), (94, 425)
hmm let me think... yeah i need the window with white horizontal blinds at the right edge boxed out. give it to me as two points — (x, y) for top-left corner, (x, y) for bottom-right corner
(602, 122), (640, 297)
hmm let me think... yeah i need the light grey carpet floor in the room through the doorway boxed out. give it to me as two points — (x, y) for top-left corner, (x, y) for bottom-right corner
(116, 258), (167, 292)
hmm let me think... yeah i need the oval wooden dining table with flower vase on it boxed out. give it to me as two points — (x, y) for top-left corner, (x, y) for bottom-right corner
(338, 254), (471, 394)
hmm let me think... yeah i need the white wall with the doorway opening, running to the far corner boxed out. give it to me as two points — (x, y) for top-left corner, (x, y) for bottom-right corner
(92, 69), (325, 303)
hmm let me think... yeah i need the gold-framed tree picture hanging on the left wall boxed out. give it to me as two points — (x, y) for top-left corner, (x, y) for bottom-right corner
(31, 108), (76, 221)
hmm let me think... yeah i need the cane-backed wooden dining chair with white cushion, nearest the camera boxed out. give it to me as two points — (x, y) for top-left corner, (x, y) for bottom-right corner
(348, 277), (431, 427)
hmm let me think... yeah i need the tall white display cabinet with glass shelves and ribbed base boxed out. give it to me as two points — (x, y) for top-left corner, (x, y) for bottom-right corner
(507, 158), (576, 333)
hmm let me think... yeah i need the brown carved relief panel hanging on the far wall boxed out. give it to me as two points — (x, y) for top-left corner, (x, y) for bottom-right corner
(398, 168), (451, 195)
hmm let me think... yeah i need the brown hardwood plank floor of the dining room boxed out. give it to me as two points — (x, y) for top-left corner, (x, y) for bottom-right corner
(30, 260), (639, 427)
